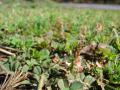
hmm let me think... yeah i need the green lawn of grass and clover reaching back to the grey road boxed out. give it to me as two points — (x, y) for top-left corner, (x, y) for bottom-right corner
(0, 2), (120, 90)
